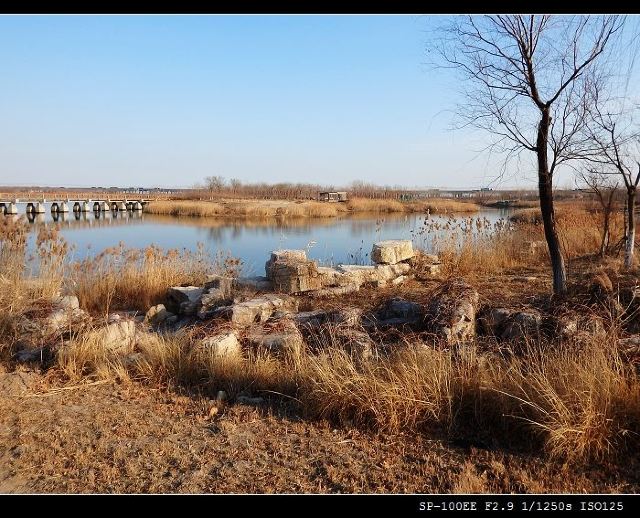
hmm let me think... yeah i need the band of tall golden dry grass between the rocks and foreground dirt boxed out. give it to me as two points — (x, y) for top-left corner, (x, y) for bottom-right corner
(58, 324), (640, 462)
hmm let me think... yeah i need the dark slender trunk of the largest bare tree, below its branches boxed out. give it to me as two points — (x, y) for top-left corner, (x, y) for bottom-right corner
(536, 107), (567, 295)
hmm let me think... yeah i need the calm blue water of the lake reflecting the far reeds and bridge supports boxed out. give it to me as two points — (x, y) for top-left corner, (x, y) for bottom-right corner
(8, 206), (505, 275)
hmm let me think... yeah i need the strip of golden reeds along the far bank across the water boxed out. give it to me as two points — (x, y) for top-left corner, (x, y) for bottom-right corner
(145, 198), (482, 218)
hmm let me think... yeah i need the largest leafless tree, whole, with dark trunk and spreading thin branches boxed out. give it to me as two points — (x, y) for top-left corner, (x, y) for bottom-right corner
(436, 15), (624, 294)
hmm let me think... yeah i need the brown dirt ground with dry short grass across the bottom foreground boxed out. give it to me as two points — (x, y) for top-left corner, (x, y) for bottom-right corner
(0, 366), (640, 493)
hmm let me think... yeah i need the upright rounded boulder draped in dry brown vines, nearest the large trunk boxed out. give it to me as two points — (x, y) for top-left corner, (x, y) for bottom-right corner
(426, 281), (479, 345)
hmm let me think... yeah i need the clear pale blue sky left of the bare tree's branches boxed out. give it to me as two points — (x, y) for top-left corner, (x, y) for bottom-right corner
(0, 16), (544, 191)
